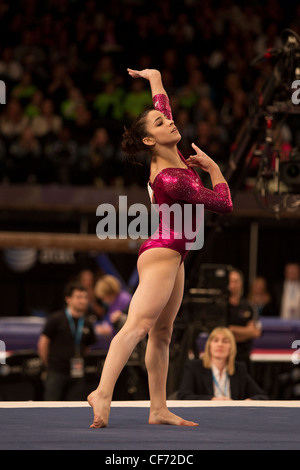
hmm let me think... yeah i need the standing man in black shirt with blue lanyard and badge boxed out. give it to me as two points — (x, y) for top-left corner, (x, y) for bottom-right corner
(38, 284), (96, 401)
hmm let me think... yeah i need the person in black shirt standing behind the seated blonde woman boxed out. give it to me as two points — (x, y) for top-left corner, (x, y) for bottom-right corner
(227, 269), (261, 365)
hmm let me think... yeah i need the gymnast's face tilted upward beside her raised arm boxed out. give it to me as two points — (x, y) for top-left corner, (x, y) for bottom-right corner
(143, 110), (181, 146)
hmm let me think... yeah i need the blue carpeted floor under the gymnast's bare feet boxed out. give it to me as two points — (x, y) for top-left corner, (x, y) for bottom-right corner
(0, 406), (300, 451)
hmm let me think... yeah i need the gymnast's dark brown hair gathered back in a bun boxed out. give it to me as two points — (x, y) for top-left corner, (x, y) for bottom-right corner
(121, 110), (151, 164)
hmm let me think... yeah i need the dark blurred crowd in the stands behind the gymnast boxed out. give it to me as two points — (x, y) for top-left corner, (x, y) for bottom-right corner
(0, 0), (300, 187)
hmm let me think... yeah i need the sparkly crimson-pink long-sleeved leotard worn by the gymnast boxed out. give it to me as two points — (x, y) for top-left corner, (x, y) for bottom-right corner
(139, 94), (232, 262)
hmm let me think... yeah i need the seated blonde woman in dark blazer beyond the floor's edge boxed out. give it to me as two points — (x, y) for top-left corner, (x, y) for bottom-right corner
(178, 327), (268, 400)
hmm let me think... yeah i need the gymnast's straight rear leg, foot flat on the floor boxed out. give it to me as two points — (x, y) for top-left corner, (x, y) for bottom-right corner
(145, 263), (197, 426)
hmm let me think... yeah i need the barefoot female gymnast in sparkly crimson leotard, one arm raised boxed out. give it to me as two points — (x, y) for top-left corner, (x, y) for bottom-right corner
(88, 69), (232, 428)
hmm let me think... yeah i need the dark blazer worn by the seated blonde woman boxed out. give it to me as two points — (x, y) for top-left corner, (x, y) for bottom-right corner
(178, 359), (269, 400)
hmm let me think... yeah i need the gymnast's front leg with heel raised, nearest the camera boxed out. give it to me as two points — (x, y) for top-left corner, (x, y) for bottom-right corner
(88, 248), (185, 428)
